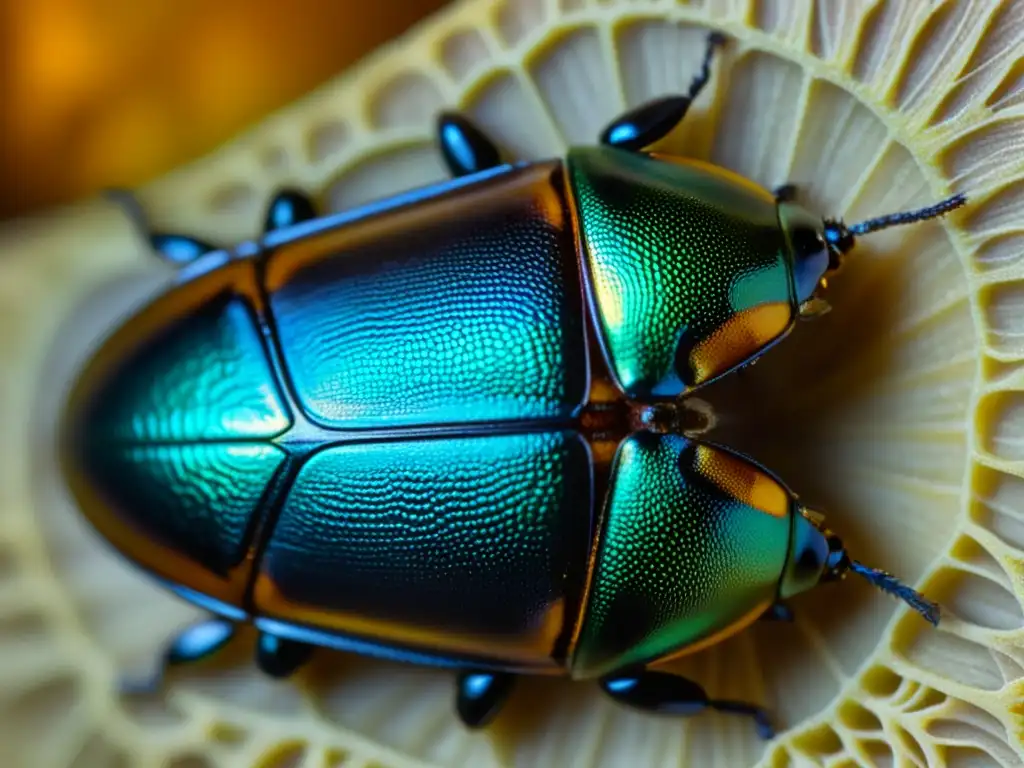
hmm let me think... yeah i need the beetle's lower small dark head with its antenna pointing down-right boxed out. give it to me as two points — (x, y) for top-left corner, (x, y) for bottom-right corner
(779, 507), (939, 625)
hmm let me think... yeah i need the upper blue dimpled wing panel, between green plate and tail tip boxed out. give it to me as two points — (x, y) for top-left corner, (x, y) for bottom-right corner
(270, 167), (586, 428)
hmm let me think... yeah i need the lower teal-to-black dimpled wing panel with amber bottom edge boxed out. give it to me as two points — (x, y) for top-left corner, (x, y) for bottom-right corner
(256, 433), (591, 665)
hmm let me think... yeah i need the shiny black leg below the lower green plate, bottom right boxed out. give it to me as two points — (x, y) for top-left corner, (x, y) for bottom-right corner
(601, 671), (775, 739)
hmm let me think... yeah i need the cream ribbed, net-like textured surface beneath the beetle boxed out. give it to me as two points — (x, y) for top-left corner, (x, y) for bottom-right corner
(0, 0), (1024, 768)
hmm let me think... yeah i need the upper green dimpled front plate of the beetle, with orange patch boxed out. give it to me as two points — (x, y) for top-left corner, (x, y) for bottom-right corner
(568, 150), (793, 397)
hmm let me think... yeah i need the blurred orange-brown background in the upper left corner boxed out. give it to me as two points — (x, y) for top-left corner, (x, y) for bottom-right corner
(0, 0), (446, 218)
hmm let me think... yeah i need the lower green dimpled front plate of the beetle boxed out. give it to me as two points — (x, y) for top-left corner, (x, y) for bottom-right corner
(573, 433), (791, 676)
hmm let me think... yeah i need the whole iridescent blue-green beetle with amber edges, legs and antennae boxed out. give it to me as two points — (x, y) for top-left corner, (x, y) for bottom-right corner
(60, 33), (965, 737)
